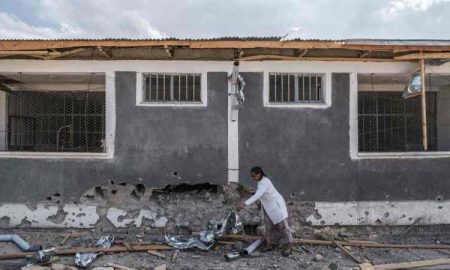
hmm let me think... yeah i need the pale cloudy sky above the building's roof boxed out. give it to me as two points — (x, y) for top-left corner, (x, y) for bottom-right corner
(0, 0), (450, 39)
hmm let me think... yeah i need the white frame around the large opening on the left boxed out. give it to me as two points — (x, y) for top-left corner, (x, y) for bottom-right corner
(0, 71), (116, 159)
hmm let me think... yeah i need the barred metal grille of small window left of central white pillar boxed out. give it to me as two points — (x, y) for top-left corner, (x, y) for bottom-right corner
(144, 73), (202, 102)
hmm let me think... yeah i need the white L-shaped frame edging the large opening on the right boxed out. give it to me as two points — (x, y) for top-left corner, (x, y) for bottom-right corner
(349, 72), (450, 160)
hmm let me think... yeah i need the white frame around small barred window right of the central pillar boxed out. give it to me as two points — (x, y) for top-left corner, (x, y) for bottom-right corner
(264, 70), (332, 109)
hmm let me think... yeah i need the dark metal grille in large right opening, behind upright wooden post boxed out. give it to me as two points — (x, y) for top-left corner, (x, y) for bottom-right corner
(358, 91), (437, 152)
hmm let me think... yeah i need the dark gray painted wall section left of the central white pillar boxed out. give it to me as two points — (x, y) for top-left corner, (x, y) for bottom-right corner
(0, 72), (228, 202)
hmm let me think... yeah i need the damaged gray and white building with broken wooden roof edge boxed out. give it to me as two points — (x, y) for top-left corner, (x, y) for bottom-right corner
(0, 38), (450, 228)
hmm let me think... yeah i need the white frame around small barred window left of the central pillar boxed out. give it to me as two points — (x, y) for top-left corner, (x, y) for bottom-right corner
(136, 70), (208, 107)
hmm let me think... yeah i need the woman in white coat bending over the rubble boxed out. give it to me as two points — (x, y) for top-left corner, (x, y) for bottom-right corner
(239, 167), (293, 256)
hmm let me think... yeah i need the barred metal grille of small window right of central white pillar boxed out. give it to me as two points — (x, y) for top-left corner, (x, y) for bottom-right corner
(269, 73), (325, 104)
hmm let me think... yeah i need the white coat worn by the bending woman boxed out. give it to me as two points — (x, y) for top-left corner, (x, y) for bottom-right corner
(245, 176), (288, 224)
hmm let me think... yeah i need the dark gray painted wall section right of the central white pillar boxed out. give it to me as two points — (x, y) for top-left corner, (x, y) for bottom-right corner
(239, 73), (450, 201)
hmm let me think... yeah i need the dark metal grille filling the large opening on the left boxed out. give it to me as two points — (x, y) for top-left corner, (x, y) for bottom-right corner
(7, 91), (105, 152)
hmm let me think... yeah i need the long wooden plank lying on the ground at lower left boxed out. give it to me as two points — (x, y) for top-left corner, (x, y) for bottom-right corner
(0, 245), (173, 260)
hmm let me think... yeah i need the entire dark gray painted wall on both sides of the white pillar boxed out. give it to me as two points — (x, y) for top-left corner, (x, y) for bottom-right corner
(0, 72), (450, 202)
